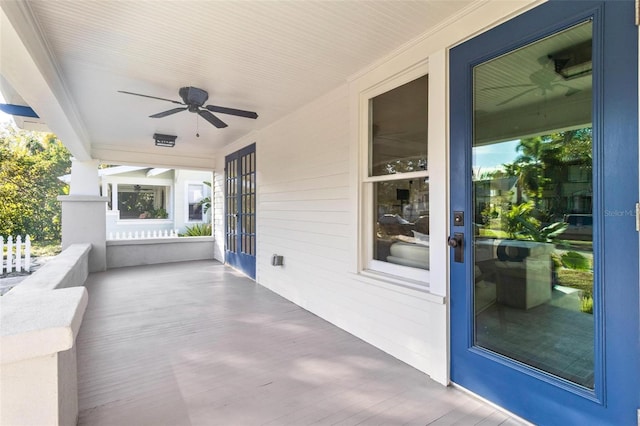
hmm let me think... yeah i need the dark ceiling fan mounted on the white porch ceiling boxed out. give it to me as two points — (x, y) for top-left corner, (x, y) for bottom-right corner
(118, 87), (258, 129)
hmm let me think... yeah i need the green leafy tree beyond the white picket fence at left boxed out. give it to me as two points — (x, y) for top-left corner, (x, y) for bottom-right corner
(0, 125), (71, 241)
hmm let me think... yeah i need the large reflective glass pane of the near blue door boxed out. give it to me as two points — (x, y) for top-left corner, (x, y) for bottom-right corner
(472, 21), (598, 389)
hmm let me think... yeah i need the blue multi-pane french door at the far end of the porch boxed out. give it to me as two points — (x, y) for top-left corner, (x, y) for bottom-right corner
(225, 144), (256, 279)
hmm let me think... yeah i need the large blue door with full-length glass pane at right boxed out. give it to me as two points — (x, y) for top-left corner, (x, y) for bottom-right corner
(449, 0), (640, 425)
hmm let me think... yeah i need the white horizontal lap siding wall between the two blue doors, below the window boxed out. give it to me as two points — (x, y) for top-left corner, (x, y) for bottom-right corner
(216, 86), (446, 382)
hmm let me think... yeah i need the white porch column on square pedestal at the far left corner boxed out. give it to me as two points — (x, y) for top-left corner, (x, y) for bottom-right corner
(58, 159), (108, 272)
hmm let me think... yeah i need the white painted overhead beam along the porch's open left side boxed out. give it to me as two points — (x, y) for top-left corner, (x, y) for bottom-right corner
(0, 1), (92, 161)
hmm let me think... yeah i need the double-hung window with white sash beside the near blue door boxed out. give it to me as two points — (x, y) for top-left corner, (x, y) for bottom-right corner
(362, 75), (429, 283)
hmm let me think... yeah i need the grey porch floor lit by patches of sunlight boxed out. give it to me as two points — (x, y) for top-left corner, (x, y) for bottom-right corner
(77, 261), (522, 426)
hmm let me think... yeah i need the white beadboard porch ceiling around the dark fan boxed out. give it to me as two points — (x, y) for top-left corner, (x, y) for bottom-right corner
(0, 0), (472, 165)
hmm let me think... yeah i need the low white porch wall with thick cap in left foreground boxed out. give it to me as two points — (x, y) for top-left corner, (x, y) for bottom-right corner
(0, 244), (92, 425)
